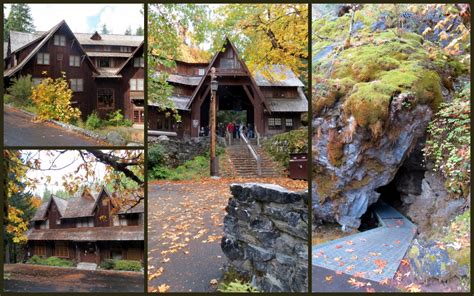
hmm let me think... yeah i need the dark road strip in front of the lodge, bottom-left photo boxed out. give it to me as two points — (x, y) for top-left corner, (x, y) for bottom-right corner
(4, 264), (145, 292)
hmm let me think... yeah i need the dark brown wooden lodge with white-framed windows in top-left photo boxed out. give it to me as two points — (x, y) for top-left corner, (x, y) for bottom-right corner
(3, 21), (144, 124)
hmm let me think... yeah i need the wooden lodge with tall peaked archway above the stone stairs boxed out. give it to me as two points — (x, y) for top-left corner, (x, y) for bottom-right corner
(148, 39), (308, 137)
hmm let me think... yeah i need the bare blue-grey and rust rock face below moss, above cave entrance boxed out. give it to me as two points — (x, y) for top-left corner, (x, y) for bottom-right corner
(313, 94), (432, 228)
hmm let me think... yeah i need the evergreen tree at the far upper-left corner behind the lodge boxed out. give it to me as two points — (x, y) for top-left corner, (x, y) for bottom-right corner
(3, 3), (35, 40)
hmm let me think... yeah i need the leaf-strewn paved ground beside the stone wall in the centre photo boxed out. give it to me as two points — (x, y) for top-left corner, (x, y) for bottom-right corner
(148, 182), (230, 292)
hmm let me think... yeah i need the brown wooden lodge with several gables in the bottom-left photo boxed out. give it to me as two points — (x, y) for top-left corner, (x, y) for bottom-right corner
(27, 188), (144, 264)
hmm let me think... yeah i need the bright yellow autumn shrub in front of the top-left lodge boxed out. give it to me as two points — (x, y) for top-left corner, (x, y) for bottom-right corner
(31, 72), (81, 123)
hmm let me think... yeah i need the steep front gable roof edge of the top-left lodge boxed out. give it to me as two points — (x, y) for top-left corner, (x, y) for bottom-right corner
(3, 20), (99, 77)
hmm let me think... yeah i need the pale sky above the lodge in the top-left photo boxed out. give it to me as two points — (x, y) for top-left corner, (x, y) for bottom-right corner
(4, 4), (144, 34)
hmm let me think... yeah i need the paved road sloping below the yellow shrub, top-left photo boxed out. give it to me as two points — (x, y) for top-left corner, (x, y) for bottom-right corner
(3, 106), (109, 147)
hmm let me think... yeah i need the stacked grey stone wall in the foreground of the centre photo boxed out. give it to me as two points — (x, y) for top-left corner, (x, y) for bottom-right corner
(221, 183), (308, 292)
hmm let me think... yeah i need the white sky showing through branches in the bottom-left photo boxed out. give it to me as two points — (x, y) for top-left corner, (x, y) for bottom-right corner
(21, 150), (106, 198)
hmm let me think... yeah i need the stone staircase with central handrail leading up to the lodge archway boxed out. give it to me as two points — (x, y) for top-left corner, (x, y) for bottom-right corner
(226, 139), (284, 178)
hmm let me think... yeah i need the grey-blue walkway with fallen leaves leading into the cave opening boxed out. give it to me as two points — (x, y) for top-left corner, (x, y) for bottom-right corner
(312, 202), (416, 285)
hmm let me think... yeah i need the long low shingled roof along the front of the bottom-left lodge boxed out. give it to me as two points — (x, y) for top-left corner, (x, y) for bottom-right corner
(27, 226), (144, 241)
